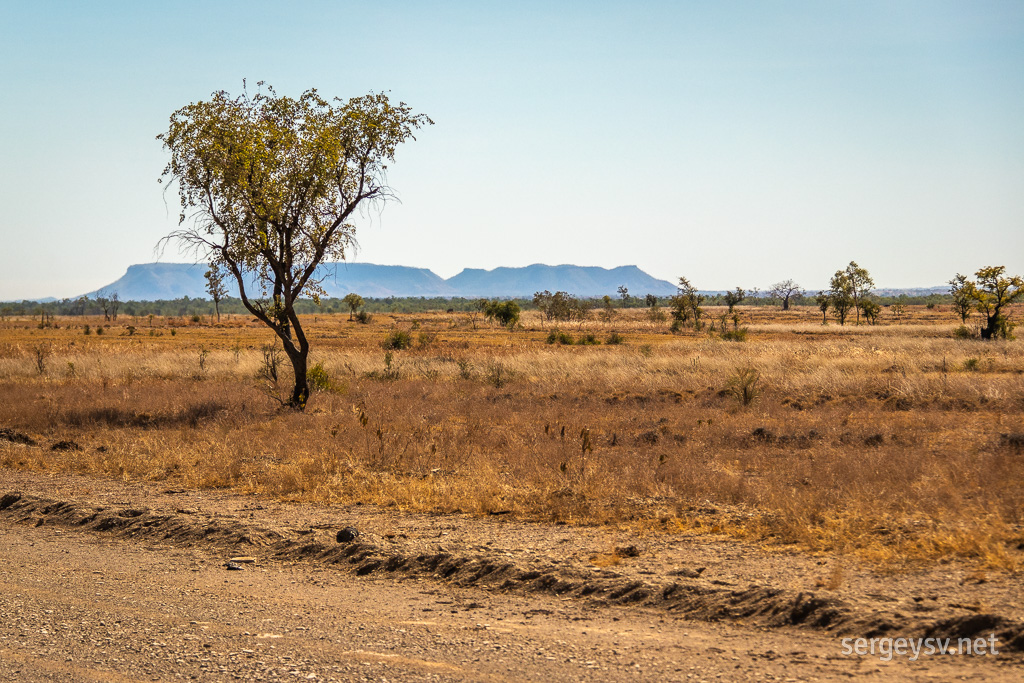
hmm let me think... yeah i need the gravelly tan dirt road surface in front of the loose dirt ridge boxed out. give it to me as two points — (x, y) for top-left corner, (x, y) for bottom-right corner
(0, 473), (1022, 681)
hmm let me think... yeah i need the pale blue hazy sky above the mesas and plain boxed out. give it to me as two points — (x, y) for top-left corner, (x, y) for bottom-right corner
(0, 0), (1024, 299)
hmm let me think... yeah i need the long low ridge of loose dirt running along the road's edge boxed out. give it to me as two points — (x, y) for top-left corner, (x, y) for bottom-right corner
(0, 493), (1024, 652)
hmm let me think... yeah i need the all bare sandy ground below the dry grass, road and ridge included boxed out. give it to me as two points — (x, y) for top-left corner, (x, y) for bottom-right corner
(0, 471), (1024, 681)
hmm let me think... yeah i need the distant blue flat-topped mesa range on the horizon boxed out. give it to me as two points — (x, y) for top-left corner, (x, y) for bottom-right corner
(86, 262), (676, 301)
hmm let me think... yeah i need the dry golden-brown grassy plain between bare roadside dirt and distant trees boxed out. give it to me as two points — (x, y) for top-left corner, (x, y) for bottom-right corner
(0, 306), (1024, 570)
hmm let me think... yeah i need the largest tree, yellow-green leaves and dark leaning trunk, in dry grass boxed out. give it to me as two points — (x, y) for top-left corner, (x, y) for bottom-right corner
(157, 82), (433, 410)
